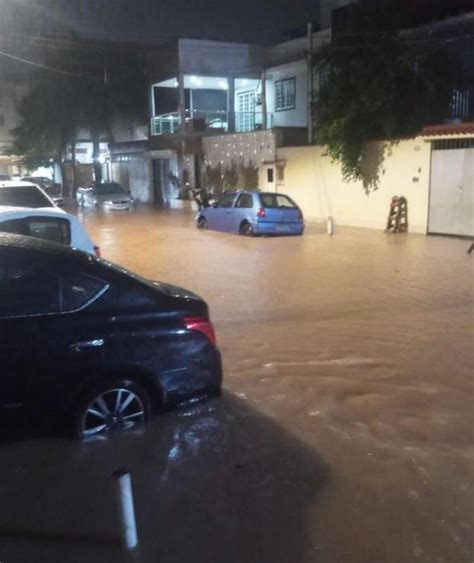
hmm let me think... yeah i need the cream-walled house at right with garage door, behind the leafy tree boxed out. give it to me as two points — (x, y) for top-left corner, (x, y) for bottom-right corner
(277, 5), (474, 237)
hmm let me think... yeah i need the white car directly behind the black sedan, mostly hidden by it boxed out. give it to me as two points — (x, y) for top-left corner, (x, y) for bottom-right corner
(0, 206), (100, 256)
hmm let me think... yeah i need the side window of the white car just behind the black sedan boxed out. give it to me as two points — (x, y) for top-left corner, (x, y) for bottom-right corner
(0, 217), (71, 245)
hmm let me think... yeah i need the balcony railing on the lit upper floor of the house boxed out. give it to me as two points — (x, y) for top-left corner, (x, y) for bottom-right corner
(150, 110), (273, 135)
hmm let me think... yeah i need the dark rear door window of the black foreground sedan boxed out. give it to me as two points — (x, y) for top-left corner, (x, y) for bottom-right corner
(0, 265), (60, 317)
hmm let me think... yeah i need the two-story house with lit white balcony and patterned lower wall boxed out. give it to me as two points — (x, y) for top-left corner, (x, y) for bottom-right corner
(110, 25), (330, 206)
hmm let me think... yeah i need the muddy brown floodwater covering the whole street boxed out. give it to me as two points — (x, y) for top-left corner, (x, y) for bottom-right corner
(0, 210), (474, 563)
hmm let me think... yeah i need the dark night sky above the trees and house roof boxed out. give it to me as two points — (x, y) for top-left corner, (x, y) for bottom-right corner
(0, 0), (319, 43)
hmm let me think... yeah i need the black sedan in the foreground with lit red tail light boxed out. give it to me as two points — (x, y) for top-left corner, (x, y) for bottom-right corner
(0, 234), (222, 438)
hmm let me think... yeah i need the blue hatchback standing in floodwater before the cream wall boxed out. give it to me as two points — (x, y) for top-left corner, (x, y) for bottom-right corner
(196, 191), (304, 236)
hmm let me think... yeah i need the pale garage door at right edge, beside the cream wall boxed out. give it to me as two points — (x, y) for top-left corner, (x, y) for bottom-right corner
(428, 143), (474, 236)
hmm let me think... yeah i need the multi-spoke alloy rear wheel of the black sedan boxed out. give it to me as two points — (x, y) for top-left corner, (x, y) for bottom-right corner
(73, 379), (151, 440)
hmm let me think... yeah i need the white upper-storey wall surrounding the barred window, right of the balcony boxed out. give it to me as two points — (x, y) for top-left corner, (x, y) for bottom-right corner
(266, 60), (308, 127)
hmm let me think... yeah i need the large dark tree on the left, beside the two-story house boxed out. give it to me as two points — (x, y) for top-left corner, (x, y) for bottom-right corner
(12, 38), (146, 192)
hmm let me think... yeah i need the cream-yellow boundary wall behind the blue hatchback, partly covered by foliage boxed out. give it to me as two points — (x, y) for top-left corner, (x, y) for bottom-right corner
(278, 137), (431, 233)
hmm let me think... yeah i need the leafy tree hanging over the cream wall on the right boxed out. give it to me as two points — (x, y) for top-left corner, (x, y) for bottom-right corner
(313, 2), (457, 192)
